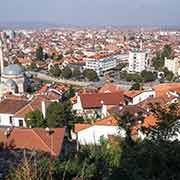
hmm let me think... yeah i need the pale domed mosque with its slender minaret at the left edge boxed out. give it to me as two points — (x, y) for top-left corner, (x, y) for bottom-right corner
(0, 41), (25, 96)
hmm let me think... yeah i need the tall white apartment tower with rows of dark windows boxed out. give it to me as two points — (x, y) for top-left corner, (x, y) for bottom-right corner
(128, 49), (150, 72)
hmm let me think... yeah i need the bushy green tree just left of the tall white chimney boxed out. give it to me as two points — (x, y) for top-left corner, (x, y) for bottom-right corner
(25, 110), (46, 128)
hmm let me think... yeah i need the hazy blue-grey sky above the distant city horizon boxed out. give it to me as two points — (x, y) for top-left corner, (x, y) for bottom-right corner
(0, 0), (180, 26)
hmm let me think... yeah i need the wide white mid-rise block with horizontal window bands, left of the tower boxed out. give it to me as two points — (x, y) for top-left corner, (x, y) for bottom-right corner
(85, 57), (117, 76)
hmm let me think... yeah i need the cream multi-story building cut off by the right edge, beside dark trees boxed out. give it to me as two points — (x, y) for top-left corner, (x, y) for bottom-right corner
(164, 58), (180, 75)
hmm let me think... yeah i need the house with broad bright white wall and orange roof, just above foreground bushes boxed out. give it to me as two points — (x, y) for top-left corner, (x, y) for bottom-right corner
(73, 116), (126, 145)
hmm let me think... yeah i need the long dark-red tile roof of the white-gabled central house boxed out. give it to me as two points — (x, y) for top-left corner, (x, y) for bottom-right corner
(80, 92), (123, 108)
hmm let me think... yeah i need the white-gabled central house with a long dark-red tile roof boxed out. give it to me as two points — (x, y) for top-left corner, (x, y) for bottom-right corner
(73, 92), (123, 118)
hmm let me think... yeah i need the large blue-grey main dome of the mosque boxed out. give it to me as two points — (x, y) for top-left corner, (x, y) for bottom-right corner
(3, 64), (24, 76)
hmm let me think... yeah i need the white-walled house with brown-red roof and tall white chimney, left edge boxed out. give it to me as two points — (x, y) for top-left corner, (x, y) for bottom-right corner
(0, 95), (52, 127)
